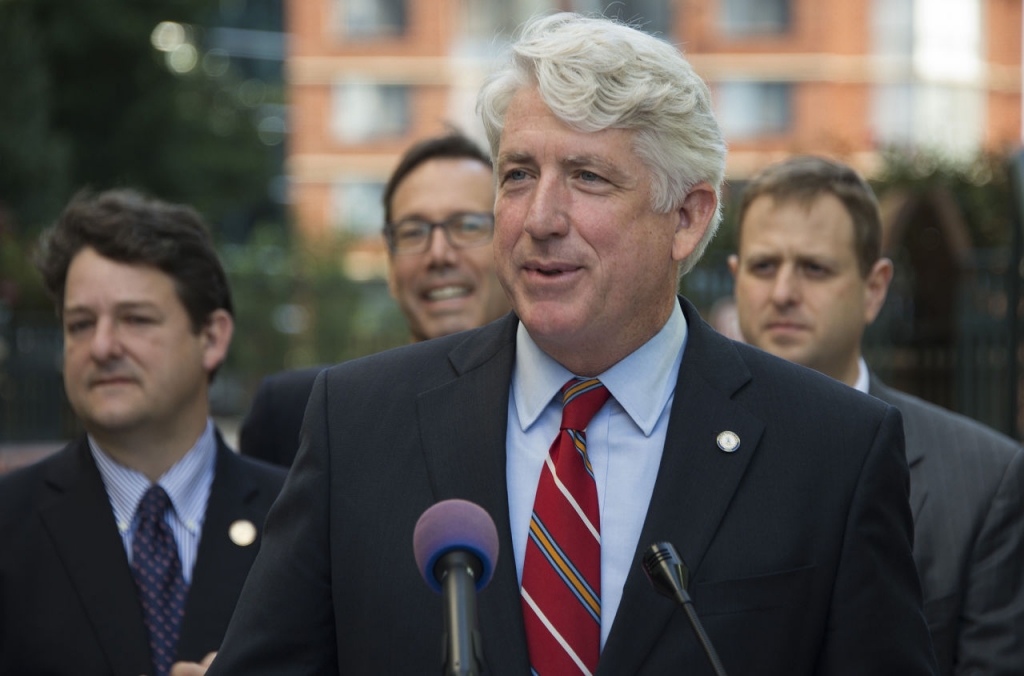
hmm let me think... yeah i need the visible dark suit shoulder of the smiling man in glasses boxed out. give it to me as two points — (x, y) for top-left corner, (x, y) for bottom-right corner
(239, 366), (327, 467)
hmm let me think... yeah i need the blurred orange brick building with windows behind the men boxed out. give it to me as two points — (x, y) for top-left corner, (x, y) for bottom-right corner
(286, 0), (1022, 250)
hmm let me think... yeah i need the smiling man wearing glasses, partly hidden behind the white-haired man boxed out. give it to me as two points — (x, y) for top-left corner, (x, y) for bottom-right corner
(239, 133), (509, 467)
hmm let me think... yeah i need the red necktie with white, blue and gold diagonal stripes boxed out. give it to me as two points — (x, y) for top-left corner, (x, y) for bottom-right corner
(521, 378), (608, 676)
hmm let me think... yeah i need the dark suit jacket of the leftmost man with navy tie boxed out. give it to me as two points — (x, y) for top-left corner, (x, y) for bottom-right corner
(0, 436), (285, 676)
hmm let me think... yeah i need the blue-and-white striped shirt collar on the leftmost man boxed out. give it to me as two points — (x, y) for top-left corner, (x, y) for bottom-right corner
(88, 419), (217, 535)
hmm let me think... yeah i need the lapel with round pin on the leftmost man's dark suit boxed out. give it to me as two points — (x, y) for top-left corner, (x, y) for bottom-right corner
(178, 434), (263, 660)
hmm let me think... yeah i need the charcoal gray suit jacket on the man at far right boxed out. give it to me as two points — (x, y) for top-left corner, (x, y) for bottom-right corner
(868, 376), (1024, 676)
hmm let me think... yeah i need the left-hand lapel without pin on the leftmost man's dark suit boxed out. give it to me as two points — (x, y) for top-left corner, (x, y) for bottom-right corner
(40, 438), (153, 674)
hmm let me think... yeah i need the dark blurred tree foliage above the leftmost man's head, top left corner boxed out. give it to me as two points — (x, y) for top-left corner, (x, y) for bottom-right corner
(0, 0), (279, 230)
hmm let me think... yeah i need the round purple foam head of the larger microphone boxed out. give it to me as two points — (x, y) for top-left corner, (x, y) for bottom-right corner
(413, 500), (498, 592)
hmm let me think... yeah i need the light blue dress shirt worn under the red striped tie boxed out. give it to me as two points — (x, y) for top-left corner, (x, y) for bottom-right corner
(506, 303), (687, 648)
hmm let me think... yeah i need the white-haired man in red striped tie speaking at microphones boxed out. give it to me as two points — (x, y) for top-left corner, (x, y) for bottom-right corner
(201, 13), (935, 676)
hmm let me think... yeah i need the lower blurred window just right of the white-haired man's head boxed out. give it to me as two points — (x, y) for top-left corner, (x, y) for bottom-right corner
(716, 82), (793, 140)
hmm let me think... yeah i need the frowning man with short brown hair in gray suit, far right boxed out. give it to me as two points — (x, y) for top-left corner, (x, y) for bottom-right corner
(729, 157), (1024, 675)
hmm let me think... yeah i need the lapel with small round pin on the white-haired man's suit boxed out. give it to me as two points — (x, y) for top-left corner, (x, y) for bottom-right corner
(597, 300), (764, 676)
